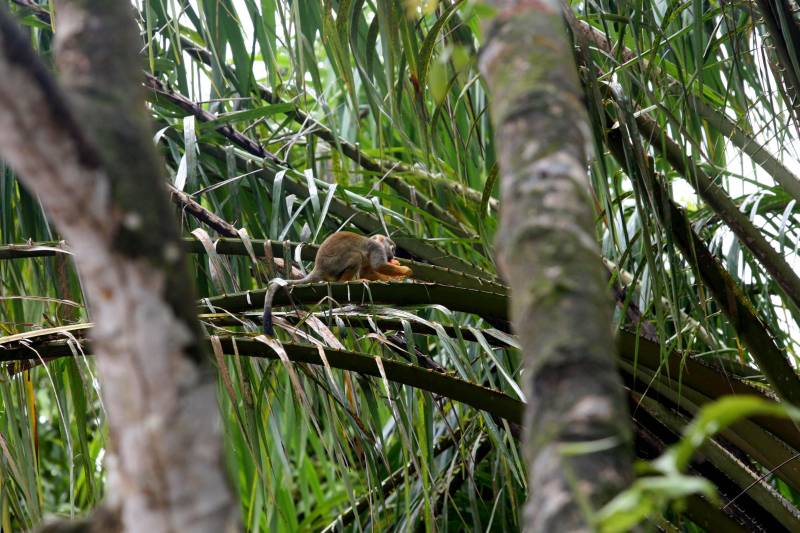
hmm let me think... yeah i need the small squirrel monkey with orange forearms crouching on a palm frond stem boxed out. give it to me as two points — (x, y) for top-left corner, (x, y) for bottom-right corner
(263, 231), (412, 335)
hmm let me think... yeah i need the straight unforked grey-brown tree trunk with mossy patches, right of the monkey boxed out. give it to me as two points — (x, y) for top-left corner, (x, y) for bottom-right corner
(481, 0), (632, 531)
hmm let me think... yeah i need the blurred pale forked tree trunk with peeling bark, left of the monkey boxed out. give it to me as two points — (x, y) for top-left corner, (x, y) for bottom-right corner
(0, 4), (236, 533)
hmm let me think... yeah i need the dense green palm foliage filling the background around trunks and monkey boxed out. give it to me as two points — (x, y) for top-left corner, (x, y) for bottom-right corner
(0, 0), (800, 531)
